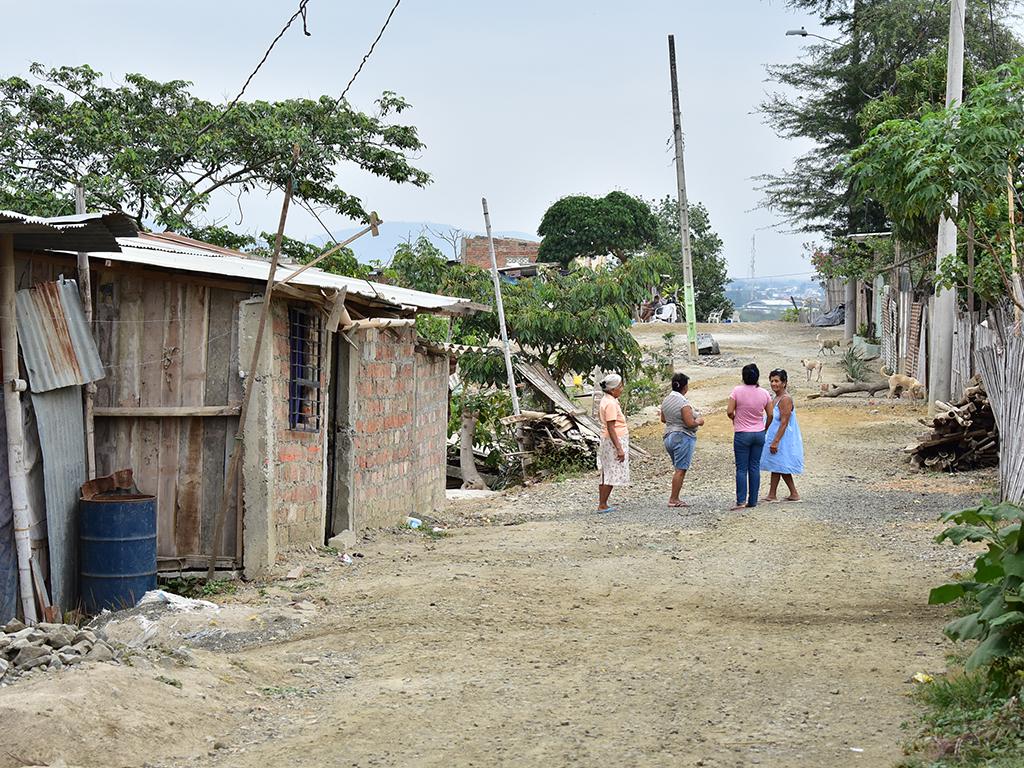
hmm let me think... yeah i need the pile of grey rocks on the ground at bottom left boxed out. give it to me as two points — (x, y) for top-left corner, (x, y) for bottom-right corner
(0, 620), (115, 680)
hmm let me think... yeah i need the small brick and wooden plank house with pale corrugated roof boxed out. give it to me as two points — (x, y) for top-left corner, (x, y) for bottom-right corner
(15, 233), (486, 575)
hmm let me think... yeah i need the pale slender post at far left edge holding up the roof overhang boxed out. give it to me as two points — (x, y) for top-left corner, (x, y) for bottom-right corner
(0, 234), (37, 624)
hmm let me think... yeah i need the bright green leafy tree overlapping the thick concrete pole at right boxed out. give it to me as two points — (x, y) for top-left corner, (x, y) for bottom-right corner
(850, 58), (1024, 307)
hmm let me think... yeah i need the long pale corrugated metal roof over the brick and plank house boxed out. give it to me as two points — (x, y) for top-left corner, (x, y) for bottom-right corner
(79, 234), (489, 313)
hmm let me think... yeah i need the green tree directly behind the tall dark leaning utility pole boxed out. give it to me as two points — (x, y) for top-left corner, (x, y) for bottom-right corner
(651, 196), (732, 317)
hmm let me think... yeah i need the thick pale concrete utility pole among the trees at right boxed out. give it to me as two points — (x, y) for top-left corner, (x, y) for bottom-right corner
(928, 0), (967, 414)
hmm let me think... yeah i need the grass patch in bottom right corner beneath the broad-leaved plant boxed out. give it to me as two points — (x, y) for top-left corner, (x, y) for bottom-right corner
(900, 666), (1024, 768)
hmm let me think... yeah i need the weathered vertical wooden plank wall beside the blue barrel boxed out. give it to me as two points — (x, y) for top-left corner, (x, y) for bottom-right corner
(93, 270), (250, 566)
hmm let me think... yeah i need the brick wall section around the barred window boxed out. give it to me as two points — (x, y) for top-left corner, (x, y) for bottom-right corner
(267, 301), (328, 548)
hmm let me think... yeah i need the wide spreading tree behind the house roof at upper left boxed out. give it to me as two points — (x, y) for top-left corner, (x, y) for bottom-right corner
(0, 65), (430, 241)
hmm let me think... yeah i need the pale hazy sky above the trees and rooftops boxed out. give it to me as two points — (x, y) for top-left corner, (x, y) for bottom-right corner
(0, 0), (820, 276)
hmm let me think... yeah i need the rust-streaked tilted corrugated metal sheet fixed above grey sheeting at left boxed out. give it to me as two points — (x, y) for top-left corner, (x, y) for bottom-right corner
(16, 280), (103, 392)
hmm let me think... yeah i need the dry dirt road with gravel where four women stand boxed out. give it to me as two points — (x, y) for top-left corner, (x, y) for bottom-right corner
(0, 324), (993, 768)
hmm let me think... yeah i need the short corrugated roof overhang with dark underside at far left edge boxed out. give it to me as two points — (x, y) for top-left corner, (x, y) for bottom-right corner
(0, 211), (138, 251)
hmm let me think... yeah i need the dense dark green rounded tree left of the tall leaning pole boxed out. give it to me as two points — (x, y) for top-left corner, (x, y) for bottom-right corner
(537, 191), (657, 266)
